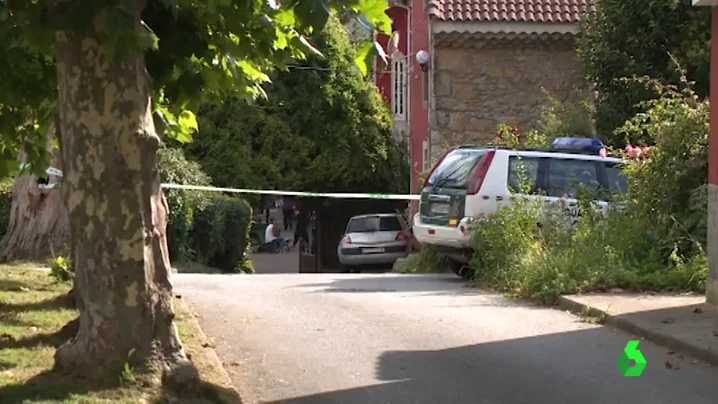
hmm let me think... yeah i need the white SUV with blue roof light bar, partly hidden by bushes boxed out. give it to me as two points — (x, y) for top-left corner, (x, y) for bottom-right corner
(413, 138), (626, 274)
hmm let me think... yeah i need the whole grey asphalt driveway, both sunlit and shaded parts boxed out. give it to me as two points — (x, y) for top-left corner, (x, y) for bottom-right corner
(174, 274), (718, 404)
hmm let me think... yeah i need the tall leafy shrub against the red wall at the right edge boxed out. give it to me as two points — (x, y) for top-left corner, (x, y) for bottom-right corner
(619, 78), (709, 260)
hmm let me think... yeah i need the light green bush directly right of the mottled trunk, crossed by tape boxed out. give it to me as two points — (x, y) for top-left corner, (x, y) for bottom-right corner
(158, 147), (211, 261)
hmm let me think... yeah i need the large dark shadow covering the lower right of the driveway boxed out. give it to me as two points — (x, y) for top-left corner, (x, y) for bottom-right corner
(273, 319), (718, 404)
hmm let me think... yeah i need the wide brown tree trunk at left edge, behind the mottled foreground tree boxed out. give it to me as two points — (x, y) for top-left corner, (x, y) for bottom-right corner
(0, 125), (69, 261)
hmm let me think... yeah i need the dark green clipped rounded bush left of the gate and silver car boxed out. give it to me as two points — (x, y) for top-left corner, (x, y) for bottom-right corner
(190, 196), (254, 273)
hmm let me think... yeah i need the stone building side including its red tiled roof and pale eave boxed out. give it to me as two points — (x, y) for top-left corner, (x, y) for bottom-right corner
(425, 0), (593, 157)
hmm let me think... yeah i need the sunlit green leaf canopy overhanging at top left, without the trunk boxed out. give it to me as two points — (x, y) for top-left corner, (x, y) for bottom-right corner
(0, 0), (391, 178)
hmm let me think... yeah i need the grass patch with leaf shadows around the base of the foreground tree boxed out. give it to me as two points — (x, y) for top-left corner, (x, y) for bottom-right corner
(0, 264), (241, 404)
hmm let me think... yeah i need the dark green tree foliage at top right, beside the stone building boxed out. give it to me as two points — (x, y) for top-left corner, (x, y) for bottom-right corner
(578, 0), (711, 147)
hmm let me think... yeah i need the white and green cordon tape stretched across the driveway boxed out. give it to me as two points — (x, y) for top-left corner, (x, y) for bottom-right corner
(38, 167), (420, 201)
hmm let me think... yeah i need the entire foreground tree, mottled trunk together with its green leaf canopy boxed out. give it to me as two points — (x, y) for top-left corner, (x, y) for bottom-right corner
(0, 0), (391, 378)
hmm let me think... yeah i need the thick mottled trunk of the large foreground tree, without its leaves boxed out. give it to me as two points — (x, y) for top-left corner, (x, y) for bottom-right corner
(54, 7), (197, 382)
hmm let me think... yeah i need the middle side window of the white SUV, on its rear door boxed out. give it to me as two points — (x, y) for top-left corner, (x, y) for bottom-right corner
(547, 158), (600, 199)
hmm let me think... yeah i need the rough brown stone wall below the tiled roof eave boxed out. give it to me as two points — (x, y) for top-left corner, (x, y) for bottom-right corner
(430, 41), (585, 157)
